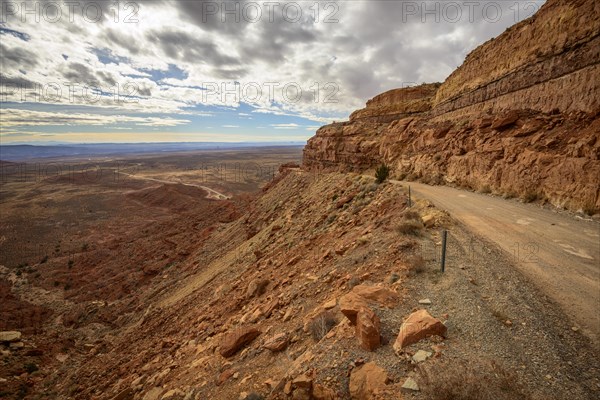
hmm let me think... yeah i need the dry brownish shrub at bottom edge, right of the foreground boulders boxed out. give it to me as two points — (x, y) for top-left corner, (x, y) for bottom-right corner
(417, 360), (532, 400)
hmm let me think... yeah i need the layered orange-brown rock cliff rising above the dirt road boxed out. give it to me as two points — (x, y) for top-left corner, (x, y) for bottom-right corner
(304, 0), (600, 213)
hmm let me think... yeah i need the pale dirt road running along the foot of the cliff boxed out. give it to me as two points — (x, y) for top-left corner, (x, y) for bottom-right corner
(400, 182), (600, 344)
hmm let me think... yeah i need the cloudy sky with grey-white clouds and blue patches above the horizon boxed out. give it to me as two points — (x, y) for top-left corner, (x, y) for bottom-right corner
(0, 0), (543, 144)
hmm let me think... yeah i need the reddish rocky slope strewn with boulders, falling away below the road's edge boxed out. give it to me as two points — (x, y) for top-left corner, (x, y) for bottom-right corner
(0, 168), (600, 400)
